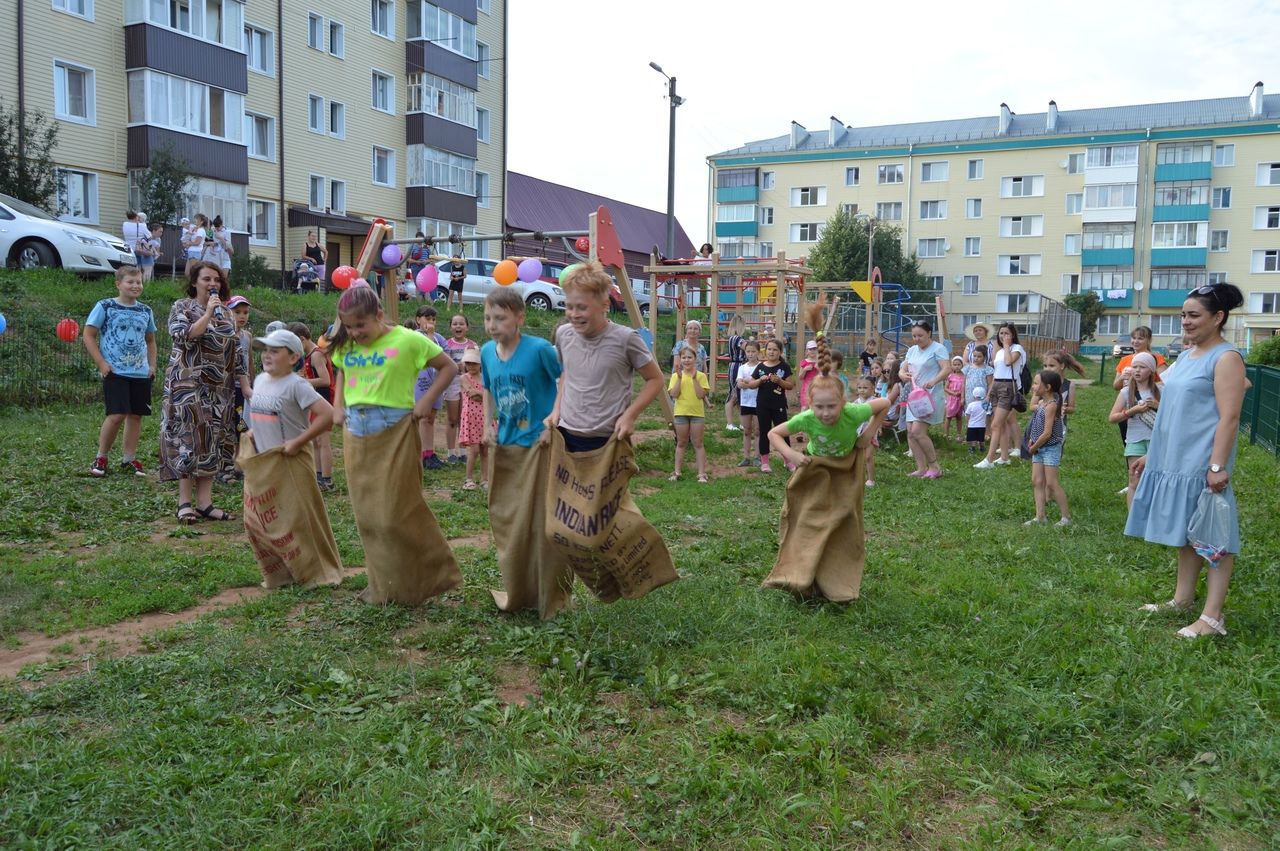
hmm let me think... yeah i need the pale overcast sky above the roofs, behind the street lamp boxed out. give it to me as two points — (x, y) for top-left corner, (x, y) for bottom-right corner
(506, 0), (1280, 252)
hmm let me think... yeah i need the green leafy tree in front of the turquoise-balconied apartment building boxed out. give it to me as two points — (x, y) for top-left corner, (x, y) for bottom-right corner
(809, 210), (934, 301)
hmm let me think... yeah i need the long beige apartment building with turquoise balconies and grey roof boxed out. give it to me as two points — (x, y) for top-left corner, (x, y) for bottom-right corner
(708, 83), (1280, 348)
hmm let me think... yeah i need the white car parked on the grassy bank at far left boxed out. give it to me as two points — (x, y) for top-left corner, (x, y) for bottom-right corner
(0, 195), (138, 275)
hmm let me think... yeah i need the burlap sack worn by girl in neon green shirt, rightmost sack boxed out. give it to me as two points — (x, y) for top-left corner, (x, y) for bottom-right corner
(762, 429), (872, 603)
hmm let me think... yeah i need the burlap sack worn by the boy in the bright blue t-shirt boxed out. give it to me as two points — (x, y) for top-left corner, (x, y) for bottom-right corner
(489, 445), (573, 621)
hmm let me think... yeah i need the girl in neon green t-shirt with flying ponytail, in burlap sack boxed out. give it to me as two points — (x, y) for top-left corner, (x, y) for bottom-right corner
(763, 305), (897, 603)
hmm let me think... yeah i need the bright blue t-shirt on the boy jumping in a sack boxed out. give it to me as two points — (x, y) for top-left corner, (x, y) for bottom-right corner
(480, 334), (561, 447)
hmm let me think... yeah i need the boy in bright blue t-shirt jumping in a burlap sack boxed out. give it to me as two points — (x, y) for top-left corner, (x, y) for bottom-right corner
(480, 287), (573, 621)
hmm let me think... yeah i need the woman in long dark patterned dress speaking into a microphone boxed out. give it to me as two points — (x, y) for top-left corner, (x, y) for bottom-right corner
(160, 261), (246, 523)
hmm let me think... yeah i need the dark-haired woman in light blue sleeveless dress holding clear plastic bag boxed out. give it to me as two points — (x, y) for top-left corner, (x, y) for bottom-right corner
(1124, 284), (1247, 639)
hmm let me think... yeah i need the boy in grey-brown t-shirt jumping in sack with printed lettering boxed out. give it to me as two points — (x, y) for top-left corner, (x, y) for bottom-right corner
(547, 260), (676, 603)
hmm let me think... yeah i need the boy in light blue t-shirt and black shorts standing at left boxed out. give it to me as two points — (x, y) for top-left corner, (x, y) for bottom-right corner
(84, 266), (156, 477)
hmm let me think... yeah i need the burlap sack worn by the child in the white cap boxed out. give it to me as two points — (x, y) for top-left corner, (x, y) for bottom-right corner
(236, 434), (342, 589)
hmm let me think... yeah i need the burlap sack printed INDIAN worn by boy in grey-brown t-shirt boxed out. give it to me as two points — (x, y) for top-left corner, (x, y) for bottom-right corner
(547, 431), (677, 603)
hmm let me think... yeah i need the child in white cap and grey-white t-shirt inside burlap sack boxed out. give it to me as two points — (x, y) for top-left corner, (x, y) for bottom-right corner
(236, 329), (342, 589)
